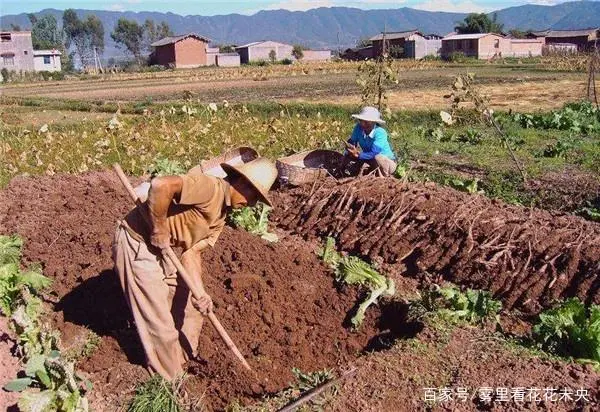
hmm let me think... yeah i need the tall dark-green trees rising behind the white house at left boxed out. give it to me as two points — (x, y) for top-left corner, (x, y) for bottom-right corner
(10, 9), (173, 71)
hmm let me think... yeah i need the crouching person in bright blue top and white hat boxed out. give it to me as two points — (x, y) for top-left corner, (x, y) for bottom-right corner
(344, 106), (398, 176)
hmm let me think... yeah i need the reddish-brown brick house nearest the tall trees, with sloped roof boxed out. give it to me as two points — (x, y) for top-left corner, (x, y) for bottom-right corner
(150, 33), (210, 69)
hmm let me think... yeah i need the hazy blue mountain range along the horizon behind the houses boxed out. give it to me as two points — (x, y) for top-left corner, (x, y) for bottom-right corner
(0, 1), (600, 58)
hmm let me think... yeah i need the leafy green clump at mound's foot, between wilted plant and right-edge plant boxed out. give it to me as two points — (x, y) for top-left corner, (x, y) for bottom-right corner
(420, 285), (502, 323)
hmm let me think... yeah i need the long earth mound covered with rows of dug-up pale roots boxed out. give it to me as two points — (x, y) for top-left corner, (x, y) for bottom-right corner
(274, 177), (600, 312)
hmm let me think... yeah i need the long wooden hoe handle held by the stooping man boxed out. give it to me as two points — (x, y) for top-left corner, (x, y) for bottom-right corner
(113, 163), (252, 370)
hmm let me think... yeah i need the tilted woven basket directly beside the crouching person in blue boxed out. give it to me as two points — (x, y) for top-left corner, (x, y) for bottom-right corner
(276, 150), (344, 186)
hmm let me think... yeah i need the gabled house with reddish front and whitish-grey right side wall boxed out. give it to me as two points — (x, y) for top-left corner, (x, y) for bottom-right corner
(369, 30), (442, 59)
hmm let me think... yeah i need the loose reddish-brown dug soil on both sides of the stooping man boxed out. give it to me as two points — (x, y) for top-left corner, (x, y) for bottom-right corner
(0, 172), (379, 410)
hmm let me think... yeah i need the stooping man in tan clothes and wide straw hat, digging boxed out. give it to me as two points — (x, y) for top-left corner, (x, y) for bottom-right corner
(113, 158), (277, 380)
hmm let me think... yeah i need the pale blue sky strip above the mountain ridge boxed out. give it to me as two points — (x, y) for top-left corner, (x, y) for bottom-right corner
(0, 0), (562, 16)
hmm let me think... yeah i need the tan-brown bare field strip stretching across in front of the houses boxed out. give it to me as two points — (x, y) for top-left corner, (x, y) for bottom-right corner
(0, 66), (585, 111)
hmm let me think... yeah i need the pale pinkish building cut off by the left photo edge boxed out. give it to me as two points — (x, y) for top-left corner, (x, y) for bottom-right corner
(0, 31), (34, 72)
